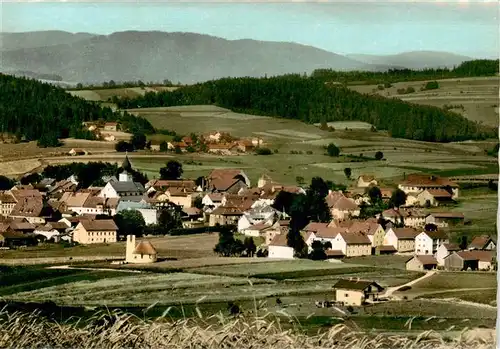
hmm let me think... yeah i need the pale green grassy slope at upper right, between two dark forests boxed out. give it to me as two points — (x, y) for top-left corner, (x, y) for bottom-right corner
(350, 77), (499, 126)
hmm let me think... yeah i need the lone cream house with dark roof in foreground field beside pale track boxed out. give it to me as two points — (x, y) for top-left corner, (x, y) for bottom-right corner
(333, 279), (384, 306)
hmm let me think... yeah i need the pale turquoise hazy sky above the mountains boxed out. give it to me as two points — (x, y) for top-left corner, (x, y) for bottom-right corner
(0, 0), (499, 57)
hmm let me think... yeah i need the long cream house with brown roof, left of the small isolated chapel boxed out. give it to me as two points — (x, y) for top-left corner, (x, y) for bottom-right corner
(73, 219), (118, 244)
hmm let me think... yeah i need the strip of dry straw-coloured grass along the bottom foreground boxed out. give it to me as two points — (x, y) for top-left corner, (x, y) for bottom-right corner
(0, 311), (495, 349)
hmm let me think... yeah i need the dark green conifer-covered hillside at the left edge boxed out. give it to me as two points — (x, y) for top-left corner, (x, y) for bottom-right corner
(0, 74), (154, 145)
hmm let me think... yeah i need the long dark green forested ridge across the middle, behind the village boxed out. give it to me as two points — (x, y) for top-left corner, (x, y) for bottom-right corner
(114, 75), (498, 142)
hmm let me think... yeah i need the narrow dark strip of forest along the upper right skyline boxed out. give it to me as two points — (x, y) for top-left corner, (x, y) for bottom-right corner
(312, 59), (499, 85)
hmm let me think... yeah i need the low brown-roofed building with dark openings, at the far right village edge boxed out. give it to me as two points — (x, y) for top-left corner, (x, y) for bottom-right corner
(444, 250), (496, 270)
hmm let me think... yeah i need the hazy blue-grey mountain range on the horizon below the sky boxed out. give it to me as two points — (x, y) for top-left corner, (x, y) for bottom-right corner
(0, 31), (476, 83)
